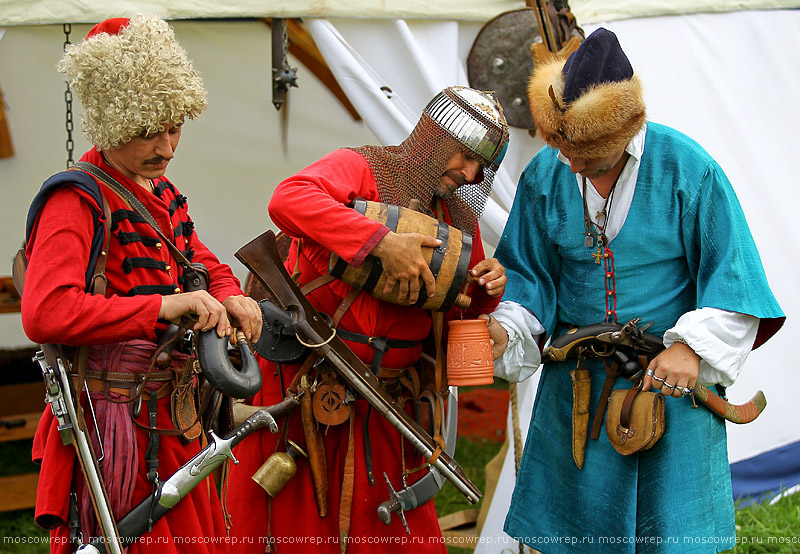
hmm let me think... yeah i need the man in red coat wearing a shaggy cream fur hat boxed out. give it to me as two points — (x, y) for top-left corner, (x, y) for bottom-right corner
(22, 16), (261, 553)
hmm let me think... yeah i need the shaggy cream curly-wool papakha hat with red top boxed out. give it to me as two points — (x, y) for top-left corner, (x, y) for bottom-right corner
(57, 15), (208, 150)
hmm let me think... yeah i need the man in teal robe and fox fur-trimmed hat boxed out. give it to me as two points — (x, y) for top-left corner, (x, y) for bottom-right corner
(489, 29), (784, 554)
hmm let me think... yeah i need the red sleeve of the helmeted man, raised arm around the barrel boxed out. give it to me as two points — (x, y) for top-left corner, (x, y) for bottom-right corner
(269, 149), (389, 266)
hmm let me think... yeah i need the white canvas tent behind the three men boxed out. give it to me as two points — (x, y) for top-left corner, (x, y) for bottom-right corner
(0, 0), (800, 552)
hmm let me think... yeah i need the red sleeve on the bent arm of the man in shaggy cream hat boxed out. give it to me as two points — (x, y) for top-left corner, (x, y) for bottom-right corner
(22, 188), (161, 346)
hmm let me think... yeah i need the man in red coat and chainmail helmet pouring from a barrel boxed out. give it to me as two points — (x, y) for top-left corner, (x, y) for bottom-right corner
(226, 87), (508, 554)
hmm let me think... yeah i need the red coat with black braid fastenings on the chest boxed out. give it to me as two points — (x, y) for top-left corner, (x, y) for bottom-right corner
(22, 150), (242, 553)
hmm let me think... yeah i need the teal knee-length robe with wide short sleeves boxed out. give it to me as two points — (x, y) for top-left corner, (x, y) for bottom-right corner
(495, 123), (784, 554)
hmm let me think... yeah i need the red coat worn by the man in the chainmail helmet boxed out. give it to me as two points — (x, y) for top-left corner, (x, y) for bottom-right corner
(227, 149), (499, 554)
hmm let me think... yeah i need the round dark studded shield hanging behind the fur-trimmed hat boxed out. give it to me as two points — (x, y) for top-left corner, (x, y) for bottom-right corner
(467, 8), (542, 130)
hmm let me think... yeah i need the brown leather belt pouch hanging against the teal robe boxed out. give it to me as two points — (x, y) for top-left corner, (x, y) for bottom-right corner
(606, 384), (664, 456)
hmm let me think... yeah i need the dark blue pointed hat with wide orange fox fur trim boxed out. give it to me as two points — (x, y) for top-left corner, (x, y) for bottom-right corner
(528, 28), (645, 159)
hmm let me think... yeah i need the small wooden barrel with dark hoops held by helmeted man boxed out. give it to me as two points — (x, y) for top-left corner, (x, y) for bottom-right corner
(328, 199), (472, 312)
